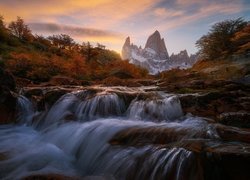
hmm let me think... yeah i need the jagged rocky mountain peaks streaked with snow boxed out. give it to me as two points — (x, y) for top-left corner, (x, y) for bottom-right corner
(122, 31), (196, 74)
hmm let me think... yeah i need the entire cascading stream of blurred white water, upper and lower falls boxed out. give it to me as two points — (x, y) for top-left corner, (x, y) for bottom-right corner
(0, 86), (250, 180)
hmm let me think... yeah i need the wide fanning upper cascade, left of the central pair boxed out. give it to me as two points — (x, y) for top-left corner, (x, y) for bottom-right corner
(35, 90), (126, 129)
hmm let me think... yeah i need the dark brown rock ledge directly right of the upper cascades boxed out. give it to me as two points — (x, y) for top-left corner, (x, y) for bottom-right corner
(179, 90), (250, 119)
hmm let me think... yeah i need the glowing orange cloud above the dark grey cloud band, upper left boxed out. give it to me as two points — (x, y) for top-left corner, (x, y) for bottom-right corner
(0, 0), (160, 28)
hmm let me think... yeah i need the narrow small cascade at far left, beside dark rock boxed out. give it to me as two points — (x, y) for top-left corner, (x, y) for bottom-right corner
(17, 95), (35, 125)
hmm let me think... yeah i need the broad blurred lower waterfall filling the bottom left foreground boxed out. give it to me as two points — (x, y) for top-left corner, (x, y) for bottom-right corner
(0, 119), (209, 180)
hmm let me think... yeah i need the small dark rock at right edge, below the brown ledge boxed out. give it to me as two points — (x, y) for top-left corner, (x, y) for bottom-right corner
(218, 112), (250, 128)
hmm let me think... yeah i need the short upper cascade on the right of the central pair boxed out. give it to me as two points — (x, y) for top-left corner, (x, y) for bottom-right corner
(128, 96), (183, 121)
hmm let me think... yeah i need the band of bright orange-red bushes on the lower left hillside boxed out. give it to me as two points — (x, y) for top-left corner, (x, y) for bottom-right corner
(6, 52), (147, 82)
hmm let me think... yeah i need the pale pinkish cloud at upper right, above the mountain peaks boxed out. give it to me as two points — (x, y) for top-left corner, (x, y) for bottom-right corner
(152, 0), (244, 30)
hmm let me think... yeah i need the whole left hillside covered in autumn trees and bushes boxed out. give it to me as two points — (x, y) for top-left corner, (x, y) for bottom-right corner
(0, 17), (147, 86)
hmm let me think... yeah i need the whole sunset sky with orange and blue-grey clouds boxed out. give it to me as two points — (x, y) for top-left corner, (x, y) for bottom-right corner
(0, 0), (250, 54)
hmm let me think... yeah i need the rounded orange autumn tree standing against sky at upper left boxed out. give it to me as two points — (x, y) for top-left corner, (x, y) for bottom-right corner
(8, 17), (33, 41)
